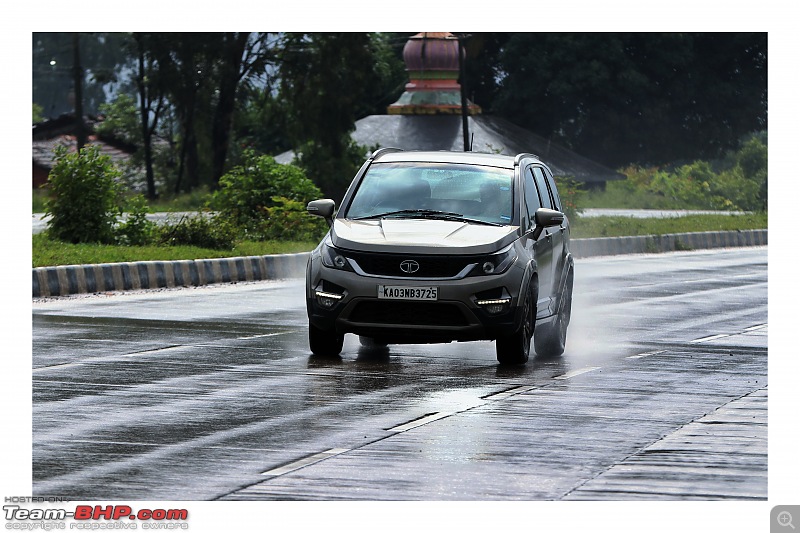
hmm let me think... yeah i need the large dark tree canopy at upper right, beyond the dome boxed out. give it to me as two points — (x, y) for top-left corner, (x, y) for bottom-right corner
(490, 33), (767, 167)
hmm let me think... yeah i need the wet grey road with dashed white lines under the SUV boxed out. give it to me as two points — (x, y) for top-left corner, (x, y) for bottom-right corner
(33, 248), (767, 500)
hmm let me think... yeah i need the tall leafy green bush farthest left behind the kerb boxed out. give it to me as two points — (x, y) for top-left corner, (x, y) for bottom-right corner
(45, 145), (122, 243)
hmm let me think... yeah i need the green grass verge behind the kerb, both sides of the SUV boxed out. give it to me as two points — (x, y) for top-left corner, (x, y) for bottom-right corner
(32, 213), (767, 267)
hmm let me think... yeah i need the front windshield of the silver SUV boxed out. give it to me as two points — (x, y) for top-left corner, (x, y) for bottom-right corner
(346, 163), (513, 224)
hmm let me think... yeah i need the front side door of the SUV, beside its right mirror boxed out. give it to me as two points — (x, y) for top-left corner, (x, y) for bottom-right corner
(523, 166), (553, 318)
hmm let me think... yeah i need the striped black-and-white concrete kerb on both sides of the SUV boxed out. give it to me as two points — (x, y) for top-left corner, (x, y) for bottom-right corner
(33, 229), (767, 298)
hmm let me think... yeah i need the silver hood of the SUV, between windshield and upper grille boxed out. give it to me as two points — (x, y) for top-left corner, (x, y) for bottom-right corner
(331, 218), (519, 254)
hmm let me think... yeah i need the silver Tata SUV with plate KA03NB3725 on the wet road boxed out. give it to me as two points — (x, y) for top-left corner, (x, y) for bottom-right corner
(306, 148), (574, 364)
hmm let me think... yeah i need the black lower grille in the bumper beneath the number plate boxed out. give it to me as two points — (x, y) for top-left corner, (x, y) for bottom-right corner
(349, 301), (469, 326)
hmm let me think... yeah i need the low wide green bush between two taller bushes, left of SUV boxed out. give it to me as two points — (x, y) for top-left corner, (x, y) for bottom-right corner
(159, 213), (239, 250)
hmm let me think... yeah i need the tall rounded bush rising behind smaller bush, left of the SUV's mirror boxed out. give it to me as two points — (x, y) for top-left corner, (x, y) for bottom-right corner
(216, 150), (322, 234)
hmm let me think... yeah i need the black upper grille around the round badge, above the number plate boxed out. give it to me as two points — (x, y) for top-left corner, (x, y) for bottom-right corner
(347, 252), (478, 278)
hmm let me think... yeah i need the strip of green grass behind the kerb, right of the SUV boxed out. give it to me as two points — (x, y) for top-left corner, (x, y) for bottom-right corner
(571, 213), (768, 239)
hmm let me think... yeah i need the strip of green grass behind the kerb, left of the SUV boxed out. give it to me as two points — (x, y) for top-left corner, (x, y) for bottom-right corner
(32, 233), (317, 268)
